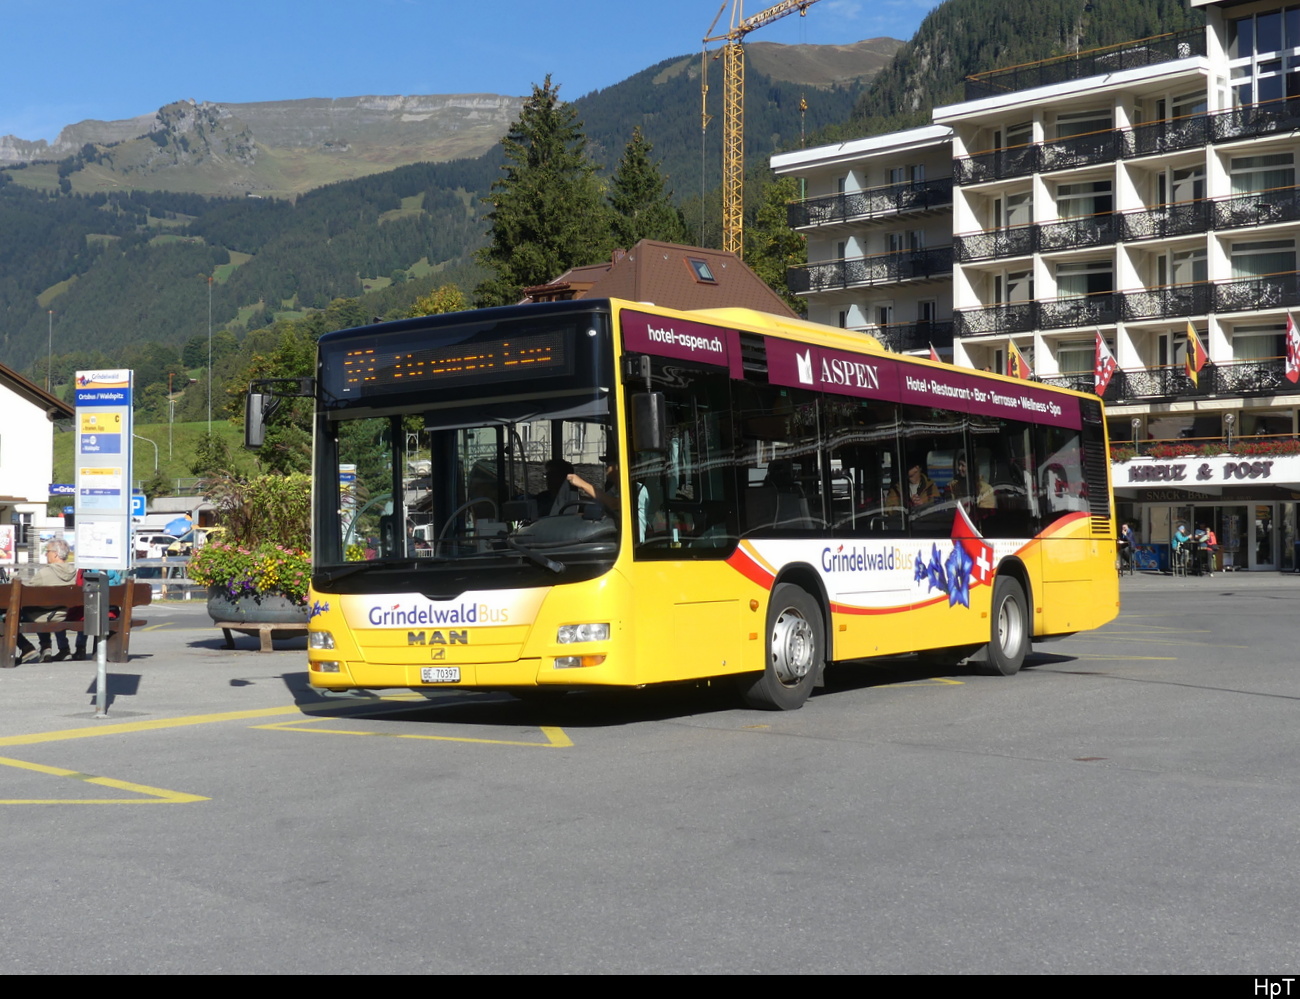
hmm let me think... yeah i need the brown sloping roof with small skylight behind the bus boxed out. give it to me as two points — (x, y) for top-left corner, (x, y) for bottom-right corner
(525, 239), (797, 317)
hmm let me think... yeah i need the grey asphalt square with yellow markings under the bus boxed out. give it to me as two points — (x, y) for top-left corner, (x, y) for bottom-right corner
(0, 574), (1300, 976)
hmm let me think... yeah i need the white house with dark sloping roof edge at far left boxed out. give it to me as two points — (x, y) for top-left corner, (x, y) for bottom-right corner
(0, 364), (73, 565)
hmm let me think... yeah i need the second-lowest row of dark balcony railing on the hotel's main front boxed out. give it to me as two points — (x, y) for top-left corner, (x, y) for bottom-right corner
(953, 272), (1300, 337)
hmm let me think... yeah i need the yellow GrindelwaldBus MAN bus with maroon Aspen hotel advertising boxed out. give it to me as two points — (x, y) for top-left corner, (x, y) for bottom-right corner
(250, 300), (1119, 709)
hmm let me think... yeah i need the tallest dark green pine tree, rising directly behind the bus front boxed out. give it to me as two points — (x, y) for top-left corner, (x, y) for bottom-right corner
(475, 75), (610, 306)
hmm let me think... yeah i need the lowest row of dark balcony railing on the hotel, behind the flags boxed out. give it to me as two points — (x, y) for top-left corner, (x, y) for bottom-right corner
(1043, 358), (1295, 405)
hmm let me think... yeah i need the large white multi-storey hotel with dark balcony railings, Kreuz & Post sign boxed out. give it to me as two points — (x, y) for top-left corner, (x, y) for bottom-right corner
(772, 0), (1300, 570)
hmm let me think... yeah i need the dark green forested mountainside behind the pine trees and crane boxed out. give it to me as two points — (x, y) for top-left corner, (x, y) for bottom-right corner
(0, 56), (879, 371)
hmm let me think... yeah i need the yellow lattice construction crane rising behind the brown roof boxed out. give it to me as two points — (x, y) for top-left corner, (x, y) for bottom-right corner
(701, 0), (816, 256)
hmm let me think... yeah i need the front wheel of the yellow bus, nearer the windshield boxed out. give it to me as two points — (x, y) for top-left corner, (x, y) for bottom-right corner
(740, 583), (826, 712)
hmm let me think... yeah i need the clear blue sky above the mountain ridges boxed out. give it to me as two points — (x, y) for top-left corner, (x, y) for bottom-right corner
(0, 0), (939, 140)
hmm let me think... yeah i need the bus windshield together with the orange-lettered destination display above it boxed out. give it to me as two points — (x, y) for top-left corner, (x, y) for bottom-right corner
(315, 300), (619, 589)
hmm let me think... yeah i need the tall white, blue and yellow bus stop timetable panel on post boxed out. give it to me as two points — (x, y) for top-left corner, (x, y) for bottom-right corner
(75, 368), (134, 570)
